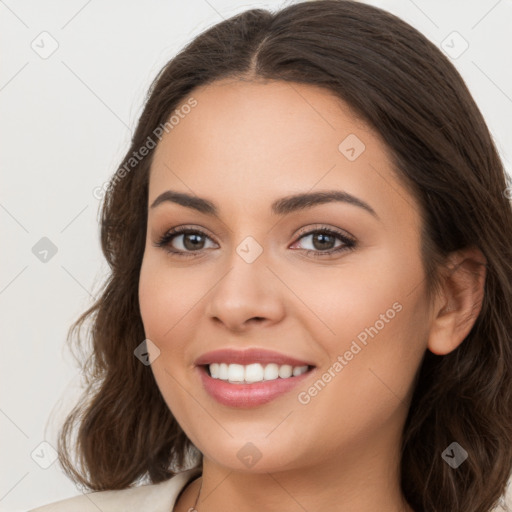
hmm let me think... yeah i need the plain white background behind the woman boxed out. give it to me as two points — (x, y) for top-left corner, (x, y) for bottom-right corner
(0, 0), (512, 511)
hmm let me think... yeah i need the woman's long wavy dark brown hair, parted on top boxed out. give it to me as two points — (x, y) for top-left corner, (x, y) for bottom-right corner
(59, 0), (512, 512)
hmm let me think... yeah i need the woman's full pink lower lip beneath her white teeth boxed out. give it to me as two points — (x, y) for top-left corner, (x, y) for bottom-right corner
(196, 366), (315, 408)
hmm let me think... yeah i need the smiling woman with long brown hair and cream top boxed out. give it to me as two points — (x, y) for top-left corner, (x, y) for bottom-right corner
(29, 0), (512, 512)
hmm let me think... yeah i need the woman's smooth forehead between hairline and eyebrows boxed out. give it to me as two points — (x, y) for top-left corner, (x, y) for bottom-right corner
(149, 79), (415, 226)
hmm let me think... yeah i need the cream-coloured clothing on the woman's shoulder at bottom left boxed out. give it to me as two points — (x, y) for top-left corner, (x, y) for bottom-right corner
(28, 468), (201, 512)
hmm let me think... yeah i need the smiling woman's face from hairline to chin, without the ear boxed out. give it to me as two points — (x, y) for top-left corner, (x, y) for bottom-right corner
(139, 80), (430, 472)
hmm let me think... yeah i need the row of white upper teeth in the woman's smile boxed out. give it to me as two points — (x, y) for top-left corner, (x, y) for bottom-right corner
(208, 363), (308, 383)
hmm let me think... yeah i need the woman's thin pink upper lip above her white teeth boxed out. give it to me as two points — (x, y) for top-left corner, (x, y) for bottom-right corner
(195, 348), (314, 366)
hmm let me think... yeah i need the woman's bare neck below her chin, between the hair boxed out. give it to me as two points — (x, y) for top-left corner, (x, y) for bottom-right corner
(174, 416), (413, 512)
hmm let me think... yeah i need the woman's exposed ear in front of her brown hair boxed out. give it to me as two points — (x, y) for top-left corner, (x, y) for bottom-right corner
(427, 247), (487, 355)
